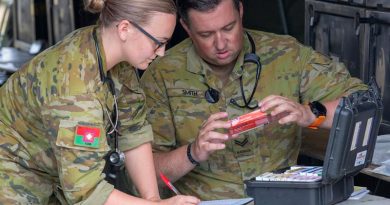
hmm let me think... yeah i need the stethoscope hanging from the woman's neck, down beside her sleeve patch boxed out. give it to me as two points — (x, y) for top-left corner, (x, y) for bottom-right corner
(92, 28), (125, 167)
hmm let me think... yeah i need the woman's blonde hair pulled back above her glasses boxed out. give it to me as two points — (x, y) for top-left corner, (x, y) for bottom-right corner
(84, 0), (176, 27)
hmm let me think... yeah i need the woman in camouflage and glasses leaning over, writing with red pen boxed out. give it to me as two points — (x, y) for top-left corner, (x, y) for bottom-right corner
(0, 0), (199, 205)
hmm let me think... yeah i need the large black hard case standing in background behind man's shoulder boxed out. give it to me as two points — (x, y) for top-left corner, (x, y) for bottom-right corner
(305, 0), (390, 134)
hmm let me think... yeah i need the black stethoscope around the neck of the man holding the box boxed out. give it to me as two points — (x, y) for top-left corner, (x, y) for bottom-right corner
(205, 32), (262, 110)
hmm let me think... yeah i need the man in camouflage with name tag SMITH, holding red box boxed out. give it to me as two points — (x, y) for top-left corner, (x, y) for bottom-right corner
(142, 0), (366, 200)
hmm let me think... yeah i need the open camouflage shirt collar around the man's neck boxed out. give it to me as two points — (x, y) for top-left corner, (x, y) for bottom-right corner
(187, 30), (251, 79)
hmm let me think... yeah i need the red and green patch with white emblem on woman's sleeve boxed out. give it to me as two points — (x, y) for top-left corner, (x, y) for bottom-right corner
(74, 126), (100, 148)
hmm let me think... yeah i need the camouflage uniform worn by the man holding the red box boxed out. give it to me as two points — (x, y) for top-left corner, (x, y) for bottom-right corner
(141, 30), (366, 200)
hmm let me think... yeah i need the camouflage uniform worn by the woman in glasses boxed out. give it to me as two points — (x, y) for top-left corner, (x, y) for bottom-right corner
(0, 27), (153, 205)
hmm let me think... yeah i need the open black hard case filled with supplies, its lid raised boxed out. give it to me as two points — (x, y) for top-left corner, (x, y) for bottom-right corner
(245, 82), (383, 205)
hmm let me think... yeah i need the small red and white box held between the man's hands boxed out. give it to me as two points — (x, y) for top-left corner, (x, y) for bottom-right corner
(229, 110), (271, 135)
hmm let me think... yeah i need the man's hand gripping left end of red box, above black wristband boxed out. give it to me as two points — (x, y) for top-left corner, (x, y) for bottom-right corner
(191, 112), (232, 162)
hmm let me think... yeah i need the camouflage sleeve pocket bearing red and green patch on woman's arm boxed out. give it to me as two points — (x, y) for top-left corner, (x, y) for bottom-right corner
(55, 120), (110, 193)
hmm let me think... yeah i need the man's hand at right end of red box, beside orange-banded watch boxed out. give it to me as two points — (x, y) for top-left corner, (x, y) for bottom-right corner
(259, 95), (316, 127)
